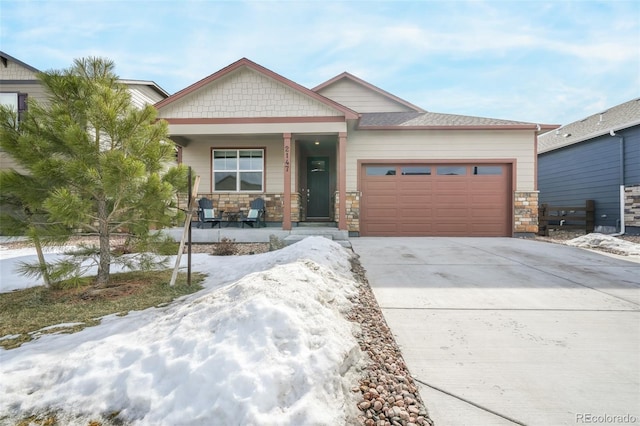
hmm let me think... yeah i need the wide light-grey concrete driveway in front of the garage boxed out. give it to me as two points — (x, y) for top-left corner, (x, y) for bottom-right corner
(351, 237), (640, 426)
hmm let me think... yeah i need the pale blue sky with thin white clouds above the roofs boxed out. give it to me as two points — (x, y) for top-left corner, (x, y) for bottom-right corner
(0, 0), (640, 125)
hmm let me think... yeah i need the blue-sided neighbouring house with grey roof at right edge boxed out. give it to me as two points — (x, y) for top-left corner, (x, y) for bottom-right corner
(538, 98), (640, 234)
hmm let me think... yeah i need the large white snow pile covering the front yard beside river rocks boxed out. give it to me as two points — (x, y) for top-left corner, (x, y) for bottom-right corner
(0, 237), (362, 425)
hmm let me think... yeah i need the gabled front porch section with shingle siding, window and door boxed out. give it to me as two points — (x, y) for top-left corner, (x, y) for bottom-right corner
(156, 58), (359, 232)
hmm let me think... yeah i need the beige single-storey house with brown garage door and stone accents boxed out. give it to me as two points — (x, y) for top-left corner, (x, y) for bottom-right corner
(155, 58), (557, 236)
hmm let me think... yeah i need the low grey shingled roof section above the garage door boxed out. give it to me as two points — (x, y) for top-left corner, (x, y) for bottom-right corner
(358, 112), (558, 131)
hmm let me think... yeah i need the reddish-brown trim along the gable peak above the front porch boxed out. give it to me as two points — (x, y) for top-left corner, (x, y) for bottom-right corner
(155, 58), (359, 119)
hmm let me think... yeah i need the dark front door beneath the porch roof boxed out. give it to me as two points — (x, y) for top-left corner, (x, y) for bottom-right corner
(307, 157), (330, 219)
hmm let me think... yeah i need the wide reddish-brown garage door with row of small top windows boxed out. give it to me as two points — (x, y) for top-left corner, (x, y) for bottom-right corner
(360, 164), (512, 236)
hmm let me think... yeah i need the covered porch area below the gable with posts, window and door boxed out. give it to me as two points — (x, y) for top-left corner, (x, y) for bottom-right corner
(174, 132), (359, 235)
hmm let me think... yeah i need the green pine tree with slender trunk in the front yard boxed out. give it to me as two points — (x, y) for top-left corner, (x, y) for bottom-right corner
(0, 58), (186, 287)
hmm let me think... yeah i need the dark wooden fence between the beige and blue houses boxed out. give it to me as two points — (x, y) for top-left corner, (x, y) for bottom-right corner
(538, 200), (596, 236)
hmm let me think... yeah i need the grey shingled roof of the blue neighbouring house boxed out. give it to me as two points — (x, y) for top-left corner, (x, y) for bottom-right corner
(538, 98), (640, 154)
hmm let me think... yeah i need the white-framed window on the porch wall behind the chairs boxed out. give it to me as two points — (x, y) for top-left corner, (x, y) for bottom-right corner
(213, 149), (264, 192)
